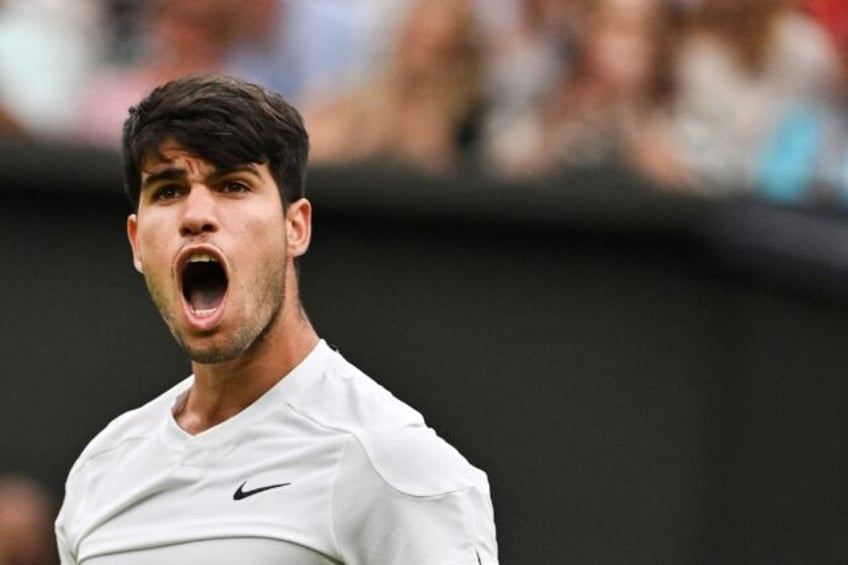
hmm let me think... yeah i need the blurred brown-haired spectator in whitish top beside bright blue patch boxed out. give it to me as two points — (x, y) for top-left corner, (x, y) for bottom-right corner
(675, 0), (838, 195)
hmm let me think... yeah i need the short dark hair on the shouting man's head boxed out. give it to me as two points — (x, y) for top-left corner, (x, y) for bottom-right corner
(123, 74), (309, 210)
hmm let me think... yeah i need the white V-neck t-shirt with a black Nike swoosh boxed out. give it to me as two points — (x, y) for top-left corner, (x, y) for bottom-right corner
(56, 341), (497, 565)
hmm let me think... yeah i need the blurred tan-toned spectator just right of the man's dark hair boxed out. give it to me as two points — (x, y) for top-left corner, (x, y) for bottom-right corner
(306, 0), (481, 171)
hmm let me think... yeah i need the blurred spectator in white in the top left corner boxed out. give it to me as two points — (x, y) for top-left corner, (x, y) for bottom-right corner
(0, 0), (102, 137)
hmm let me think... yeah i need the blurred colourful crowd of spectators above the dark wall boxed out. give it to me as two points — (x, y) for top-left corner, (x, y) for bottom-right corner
(0, 0), (848, 203)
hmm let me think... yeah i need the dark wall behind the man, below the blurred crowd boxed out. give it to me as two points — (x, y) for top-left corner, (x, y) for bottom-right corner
(0, 140), (848, 565)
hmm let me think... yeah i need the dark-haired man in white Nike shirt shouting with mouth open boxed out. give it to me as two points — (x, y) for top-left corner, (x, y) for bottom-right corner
(56, 76), (497, 565)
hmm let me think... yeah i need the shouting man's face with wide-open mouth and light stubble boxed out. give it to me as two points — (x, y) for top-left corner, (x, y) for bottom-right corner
(127, 142), (294, 363)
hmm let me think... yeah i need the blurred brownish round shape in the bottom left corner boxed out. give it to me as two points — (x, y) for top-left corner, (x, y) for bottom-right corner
(0, 475), (59, 565)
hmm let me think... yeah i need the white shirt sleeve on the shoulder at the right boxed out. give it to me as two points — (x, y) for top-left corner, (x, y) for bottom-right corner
(333, 428), (498, 565)
